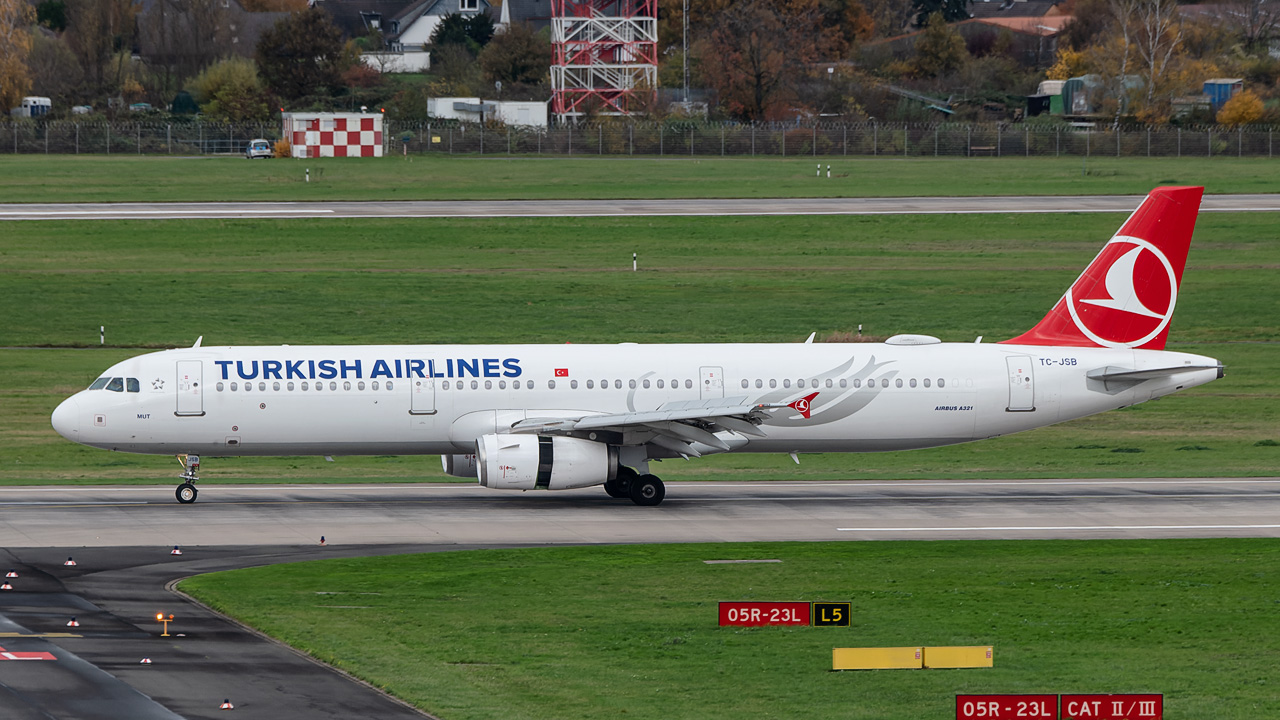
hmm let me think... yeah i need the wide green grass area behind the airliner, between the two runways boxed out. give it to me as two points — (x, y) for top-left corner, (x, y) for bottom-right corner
(0, 213), (1280, 483)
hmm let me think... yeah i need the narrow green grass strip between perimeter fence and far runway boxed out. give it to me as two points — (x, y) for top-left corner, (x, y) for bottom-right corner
(0, 154), (1276, 202)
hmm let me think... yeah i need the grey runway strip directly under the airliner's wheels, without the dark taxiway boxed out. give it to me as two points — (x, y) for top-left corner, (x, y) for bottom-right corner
(0, 478), (1280, 547)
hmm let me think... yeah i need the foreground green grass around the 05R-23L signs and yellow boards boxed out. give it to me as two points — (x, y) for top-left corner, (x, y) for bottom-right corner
(180, 539), (1280, 720)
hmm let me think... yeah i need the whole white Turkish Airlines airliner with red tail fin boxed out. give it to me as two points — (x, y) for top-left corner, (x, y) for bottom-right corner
(52, 187), (1222, 505)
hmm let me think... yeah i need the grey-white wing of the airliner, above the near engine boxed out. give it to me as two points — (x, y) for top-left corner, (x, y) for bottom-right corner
(511, 396), (786, 457)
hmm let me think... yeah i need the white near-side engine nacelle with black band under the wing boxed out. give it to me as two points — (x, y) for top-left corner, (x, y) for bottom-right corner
(476, 434), (618, 489)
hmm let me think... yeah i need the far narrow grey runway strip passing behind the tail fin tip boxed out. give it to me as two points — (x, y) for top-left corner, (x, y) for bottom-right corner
(0, 195), (1280, 220)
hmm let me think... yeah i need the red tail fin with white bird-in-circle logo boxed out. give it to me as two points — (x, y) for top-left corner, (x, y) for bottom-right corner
(1005, 187), (1203, 350)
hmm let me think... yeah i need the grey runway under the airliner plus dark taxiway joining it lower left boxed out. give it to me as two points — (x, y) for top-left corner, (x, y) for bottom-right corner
(0, 478), (1280, 720)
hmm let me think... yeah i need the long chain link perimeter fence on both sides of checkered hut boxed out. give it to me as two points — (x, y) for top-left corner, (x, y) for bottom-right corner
(0, 120), (1276, 158)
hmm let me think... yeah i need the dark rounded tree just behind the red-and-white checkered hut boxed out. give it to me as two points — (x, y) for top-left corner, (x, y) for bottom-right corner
(255, 8), (347, 100)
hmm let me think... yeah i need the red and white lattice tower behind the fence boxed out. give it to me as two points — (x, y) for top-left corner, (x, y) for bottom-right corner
(552, 0), (658, 122)
